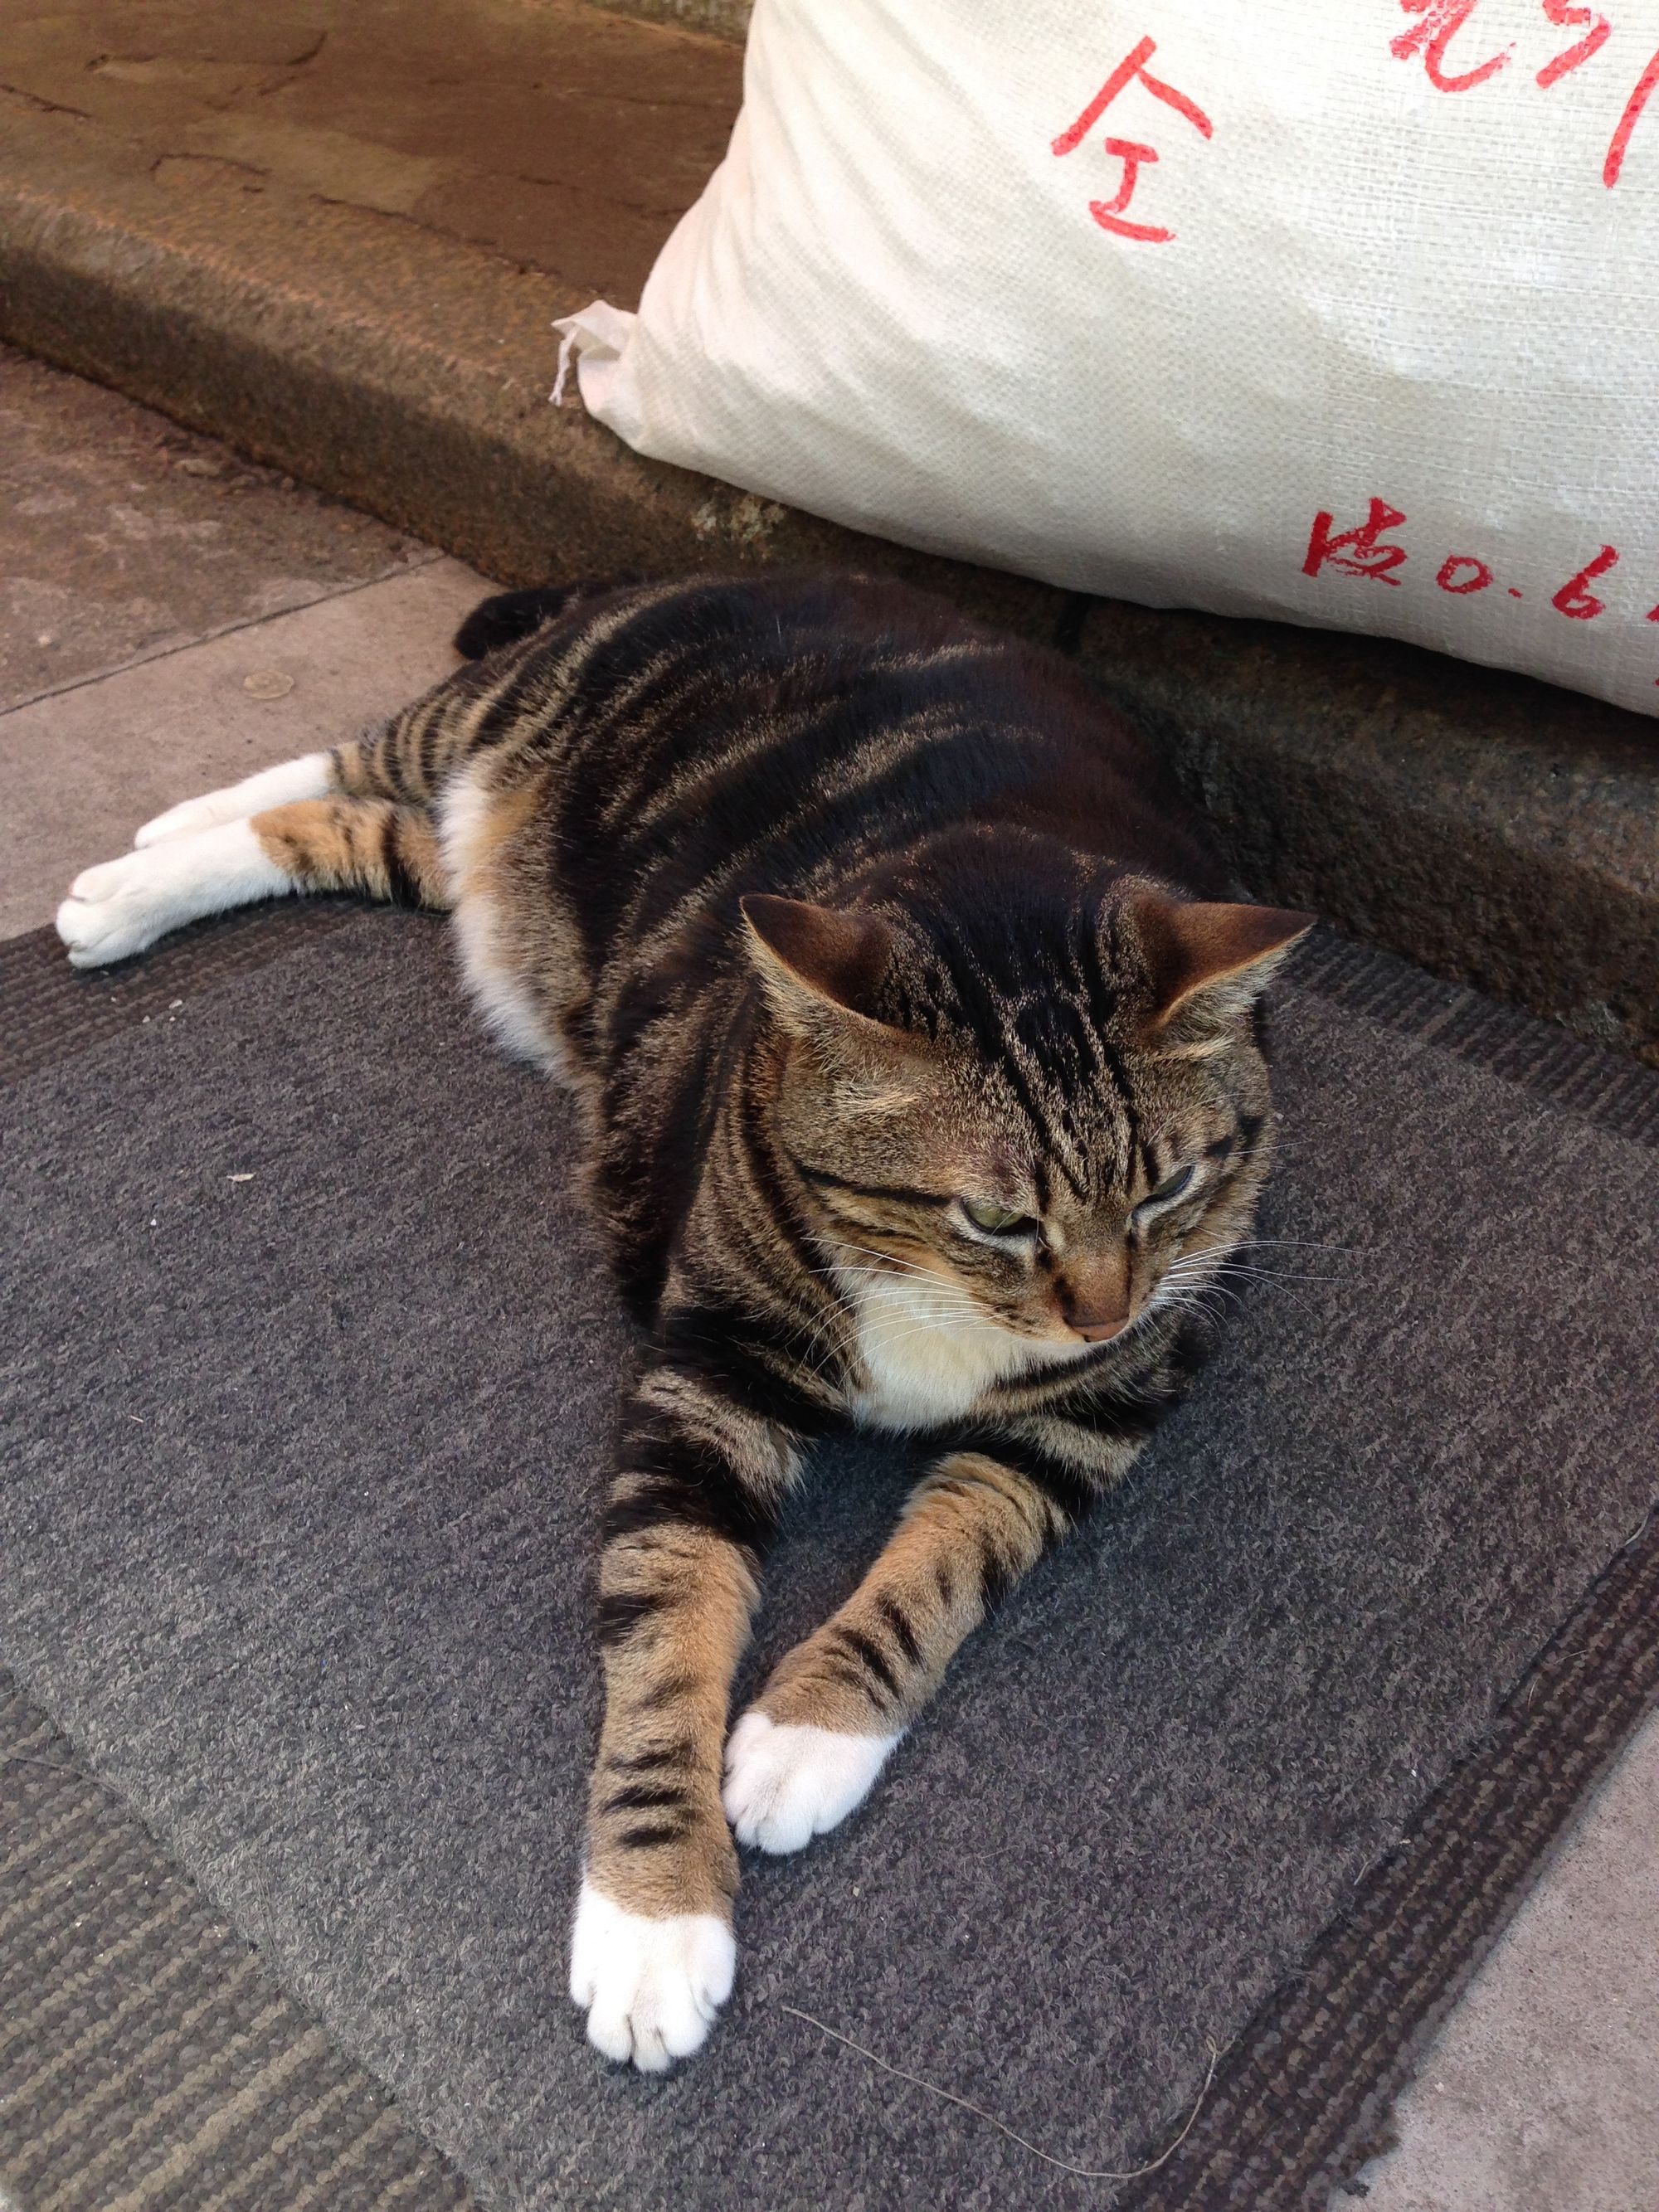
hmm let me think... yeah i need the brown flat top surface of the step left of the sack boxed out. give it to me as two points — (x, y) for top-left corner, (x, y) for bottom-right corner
(0, 0), (741, 299)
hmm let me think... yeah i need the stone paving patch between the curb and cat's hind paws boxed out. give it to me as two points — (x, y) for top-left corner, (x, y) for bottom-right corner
(0, 349), (489, 936)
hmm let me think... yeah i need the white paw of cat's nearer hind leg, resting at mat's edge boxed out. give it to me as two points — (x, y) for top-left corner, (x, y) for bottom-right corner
(57, 823), (292, 966)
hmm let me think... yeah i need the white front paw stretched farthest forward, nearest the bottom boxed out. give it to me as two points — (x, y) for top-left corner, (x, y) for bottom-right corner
(571, 1883), (737, 2073)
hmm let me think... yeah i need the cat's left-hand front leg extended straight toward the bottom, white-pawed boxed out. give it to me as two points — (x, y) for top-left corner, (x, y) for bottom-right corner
(571, 1367), (796, 2073)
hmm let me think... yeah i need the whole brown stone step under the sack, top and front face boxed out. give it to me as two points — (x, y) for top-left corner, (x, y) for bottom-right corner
(0, 0), (1659, 1062)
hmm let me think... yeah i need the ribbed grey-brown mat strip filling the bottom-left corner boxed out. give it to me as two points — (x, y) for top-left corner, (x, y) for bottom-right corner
(0, 1675), (474, 2212)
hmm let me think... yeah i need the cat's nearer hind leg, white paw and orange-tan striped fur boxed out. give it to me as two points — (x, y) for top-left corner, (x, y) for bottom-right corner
(57, 796), (451, 966)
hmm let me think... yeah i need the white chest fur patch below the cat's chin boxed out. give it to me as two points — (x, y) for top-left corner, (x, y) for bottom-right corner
(843, 1276), (1088, 1429)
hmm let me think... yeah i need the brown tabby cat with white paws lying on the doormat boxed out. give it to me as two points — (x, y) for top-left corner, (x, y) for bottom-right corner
(57, 575), (1310, 2073)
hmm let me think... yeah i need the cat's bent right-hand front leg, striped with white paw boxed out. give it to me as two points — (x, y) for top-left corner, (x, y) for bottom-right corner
(723, 1422), (1132, 1851)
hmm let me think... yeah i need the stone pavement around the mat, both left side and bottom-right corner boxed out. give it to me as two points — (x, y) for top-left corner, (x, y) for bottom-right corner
(0, 336), (1659, 2212)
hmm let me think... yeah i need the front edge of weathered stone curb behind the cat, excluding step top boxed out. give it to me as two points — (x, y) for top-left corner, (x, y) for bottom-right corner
(0, 90), (1659, 1064)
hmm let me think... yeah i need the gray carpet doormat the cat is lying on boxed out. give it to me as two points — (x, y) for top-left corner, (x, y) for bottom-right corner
(0, 916), (1659, 2212)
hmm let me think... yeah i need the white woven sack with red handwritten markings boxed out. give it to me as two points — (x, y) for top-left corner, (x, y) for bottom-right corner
(562, 0), (1659, 712)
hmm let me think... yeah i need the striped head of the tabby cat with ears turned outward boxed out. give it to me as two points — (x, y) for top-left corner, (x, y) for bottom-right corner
(743, 878), (1311, 1356)
